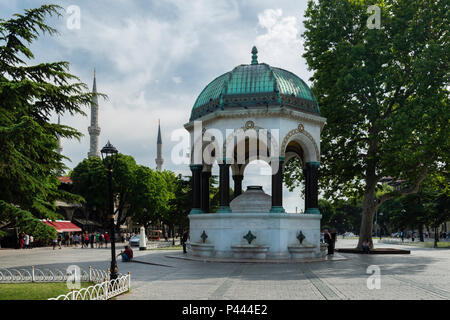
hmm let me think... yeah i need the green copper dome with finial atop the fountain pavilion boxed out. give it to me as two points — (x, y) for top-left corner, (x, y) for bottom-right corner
(190, 47), (319, 121)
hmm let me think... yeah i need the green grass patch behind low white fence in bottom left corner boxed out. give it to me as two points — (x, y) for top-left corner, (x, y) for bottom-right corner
(0, 282), (94, 300)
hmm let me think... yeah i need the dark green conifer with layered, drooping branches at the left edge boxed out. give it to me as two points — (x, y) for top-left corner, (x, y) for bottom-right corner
(0, 5), (93, 239)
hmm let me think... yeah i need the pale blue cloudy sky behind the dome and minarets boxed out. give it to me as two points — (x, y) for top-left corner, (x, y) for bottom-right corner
(0, 0), (311, 212)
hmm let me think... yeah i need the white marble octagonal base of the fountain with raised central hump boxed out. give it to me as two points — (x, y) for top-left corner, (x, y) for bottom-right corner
(189, 186), (322, 260)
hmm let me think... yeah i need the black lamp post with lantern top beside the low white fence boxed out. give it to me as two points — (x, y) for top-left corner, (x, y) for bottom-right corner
(101, 141), (119, 280)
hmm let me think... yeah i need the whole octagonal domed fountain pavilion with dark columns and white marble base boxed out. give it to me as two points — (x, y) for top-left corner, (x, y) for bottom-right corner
(185, 47), (326, 261)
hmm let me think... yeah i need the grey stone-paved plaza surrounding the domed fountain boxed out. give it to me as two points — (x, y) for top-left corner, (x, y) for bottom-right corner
(0, 239), (450, 300)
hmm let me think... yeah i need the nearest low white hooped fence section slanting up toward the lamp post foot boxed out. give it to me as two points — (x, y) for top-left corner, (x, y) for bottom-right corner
(48, 273), (131, 300)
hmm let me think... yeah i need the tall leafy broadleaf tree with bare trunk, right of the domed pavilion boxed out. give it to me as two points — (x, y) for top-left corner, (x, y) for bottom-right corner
(297, 0), (450, 248)
